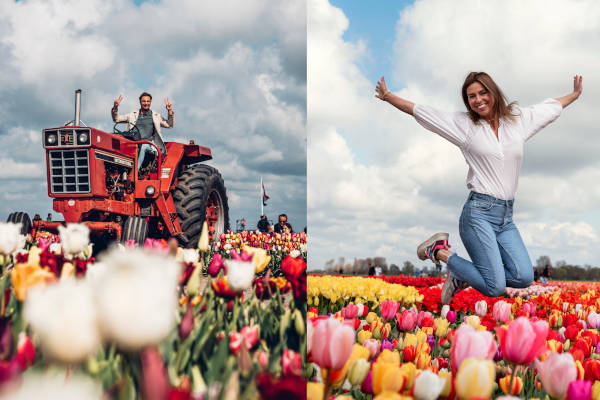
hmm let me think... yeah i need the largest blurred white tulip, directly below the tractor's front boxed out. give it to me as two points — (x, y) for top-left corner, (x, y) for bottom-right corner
(90, 248), (181, 350)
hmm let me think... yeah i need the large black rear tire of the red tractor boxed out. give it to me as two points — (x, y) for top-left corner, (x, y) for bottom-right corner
(173, 164), (229, 247)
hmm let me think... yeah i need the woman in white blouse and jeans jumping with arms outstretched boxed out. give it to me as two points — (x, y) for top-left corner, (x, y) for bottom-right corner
(376, 72), (583, 304)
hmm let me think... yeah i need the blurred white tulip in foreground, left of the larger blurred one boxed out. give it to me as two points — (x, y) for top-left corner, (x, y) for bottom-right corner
(24, 279), (101, 363)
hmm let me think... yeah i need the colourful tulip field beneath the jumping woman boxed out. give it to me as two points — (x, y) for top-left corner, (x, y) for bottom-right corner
(307, 275), (600, 400)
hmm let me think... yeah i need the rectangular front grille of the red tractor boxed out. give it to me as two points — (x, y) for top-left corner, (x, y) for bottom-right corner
(48, 149), (90, 194)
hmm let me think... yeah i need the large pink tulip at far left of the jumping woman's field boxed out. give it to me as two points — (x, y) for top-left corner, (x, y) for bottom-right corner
(311, 318), (355, 370)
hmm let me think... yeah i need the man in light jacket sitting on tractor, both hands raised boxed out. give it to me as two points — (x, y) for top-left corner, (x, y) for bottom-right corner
(111, 92), (174, 177)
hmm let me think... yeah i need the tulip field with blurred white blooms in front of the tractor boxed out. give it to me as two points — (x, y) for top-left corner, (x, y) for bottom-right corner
(0, 223), (306, 400)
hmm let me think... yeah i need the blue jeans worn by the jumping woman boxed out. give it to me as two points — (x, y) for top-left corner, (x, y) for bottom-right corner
(447, 192), (533, 297)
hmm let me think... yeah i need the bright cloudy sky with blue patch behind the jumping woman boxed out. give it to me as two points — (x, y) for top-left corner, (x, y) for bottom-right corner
(307, 0), (600, 269)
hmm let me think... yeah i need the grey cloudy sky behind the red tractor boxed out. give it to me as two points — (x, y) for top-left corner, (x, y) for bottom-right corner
(0, 0), (306, 230)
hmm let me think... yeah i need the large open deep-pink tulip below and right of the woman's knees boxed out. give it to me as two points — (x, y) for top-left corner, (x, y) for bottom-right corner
(496, 317), (548, 364)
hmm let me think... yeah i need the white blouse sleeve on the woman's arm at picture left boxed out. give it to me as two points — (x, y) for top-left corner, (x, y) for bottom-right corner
(413, 104), (469, 147)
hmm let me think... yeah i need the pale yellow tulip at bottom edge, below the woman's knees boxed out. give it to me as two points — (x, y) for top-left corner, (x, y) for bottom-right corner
(454, 357), (496, 399)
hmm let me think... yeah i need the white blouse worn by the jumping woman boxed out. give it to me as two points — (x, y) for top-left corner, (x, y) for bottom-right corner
(413, 99), (562, 200)
